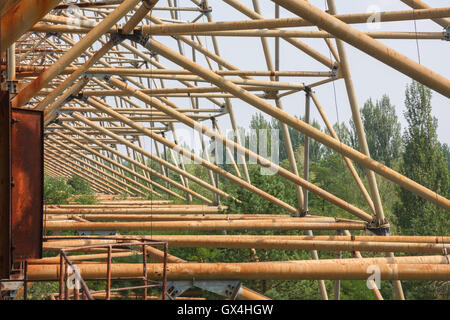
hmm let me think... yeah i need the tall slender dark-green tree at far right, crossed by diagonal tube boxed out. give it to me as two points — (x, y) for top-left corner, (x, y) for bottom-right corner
(394, 82), (450, 235)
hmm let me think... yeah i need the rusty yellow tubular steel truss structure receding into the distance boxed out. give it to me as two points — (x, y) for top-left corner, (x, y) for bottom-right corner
(0, 0), (450, 299)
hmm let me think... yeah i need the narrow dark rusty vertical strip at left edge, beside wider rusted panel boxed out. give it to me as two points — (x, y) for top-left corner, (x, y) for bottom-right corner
(0, 91), (11, 279)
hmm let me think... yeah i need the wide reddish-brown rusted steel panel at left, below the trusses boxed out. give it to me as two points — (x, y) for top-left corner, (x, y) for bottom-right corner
(11, 108), (44, 262)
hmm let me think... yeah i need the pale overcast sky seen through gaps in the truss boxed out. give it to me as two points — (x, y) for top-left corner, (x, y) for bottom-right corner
(150, 0), (450, 151)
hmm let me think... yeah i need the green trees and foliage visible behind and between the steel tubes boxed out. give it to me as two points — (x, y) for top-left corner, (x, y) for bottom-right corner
(37, 83), (450, 300)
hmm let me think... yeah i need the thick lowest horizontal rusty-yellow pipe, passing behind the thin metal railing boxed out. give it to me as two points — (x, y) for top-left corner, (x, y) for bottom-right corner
(27, 262), (450, 281)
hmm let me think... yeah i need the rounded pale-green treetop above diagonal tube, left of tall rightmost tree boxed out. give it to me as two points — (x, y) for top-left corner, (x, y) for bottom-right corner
(350, 95), (402, 167)
